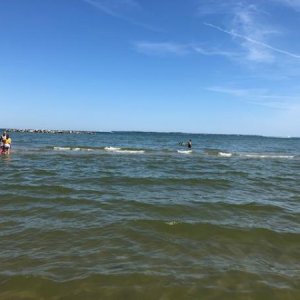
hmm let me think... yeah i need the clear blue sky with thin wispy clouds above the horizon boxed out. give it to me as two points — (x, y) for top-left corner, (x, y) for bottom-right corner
(0, 0), (300, 137)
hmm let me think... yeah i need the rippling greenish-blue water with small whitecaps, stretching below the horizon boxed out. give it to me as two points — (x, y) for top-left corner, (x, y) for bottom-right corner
(0, 132), (300, 300)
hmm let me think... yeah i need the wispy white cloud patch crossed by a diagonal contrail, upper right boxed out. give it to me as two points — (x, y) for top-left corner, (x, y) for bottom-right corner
(198, 0), (300, 67)
